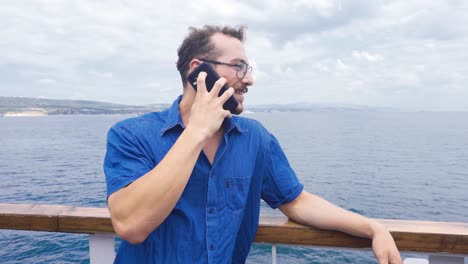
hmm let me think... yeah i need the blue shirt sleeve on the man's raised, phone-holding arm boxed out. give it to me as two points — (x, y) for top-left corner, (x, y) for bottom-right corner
(104, 124), (156, 197)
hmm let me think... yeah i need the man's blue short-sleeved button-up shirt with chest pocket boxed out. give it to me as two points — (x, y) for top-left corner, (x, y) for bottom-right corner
(104, 97), (303, 263)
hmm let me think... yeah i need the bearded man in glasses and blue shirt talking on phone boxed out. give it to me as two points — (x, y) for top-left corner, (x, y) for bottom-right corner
(104, 26), (402, 263)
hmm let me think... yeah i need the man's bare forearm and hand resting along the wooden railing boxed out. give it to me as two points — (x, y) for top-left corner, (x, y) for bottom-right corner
(279, 191), (403, 264)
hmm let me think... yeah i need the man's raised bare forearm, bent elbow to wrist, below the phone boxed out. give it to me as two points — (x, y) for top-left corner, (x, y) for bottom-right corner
(108, 129), (203, 243)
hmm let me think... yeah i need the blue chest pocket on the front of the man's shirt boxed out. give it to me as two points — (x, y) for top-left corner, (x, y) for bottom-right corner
(225, 177), (250, 211)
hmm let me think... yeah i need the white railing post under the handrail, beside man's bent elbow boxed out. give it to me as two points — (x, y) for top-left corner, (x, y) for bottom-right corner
(89, 234), (115, 264)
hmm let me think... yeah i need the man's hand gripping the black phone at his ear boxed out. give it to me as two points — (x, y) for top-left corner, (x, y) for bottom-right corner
(187, 69), (234, 140)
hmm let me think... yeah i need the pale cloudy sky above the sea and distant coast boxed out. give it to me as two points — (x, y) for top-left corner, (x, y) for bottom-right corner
(0, 0), (468, 111)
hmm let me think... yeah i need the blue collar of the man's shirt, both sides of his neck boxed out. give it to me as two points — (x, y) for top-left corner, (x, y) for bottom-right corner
(161, 95), (247, 136)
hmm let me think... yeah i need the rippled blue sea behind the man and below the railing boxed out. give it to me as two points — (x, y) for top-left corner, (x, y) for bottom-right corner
(0, 110), (468, 263)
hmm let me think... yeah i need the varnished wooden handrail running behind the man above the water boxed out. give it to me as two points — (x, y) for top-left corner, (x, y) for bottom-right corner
(0, 203), (468, 255)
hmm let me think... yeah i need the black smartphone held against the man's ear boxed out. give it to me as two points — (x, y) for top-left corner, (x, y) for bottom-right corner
(187, 62), (239, 113)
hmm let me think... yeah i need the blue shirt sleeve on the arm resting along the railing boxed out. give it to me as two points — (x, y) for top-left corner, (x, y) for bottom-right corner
(262, 133), (304, 209)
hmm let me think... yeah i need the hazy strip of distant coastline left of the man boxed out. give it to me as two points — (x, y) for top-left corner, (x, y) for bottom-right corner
(0, 96), (169, 115)
